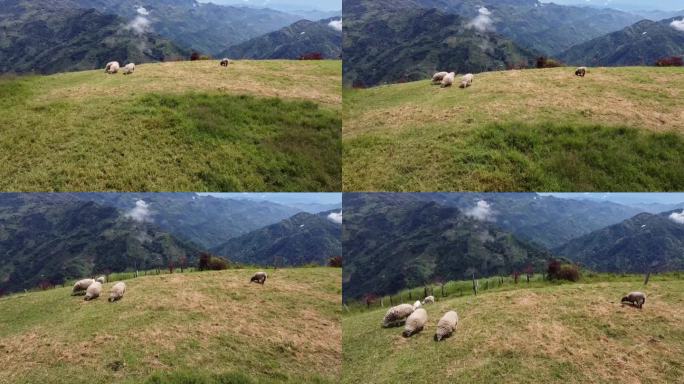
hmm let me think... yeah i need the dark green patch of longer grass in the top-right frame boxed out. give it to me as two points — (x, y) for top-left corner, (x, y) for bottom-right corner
(454, 123), (684, 191)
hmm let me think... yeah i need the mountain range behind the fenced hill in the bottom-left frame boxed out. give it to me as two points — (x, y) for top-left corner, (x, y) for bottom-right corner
(0, 193), (342, 291)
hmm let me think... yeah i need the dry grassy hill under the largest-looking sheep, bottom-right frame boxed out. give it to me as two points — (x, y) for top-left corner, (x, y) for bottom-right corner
(342, 280), (684, 383)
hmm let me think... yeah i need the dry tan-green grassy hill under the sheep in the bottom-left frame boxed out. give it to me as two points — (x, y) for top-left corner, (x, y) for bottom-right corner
(0, 268), (341, 384)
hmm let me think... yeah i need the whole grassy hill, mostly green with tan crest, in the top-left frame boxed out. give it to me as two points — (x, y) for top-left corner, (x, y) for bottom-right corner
(0, 61), (341, 191)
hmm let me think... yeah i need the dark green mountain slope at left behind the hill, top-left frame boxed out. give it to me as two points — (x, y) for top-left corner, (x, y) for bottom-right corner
(0, 0), (189, 74)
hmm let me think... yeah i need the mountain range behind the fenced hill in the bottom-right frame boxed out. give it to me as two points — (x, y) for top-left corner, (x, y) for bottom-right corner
(342, 193), (684, 298)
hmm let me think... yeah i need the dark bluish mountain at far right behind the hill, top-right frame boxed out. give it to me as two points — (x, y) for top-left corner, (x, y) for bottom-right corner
(558, 18), (684, 67)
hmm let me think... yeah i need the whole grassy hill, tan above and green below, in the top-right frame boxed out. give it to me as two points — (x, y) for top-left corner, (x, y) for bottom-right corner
(343, 67), (684, 191)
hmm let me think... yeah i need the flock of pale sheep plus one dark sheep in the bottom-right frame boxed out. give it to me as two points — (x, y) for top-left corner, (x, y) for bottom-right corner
(382, 292), (646, 341)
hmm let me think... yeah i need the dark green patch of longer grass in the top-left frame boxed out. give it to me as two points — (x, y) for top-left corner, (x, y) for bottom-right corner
(131, 94), (342, 191)
